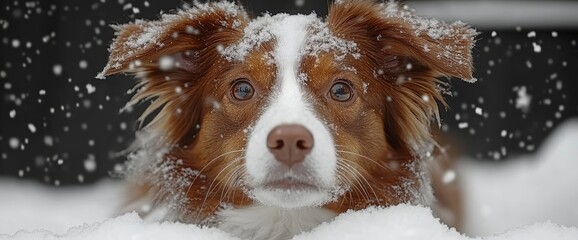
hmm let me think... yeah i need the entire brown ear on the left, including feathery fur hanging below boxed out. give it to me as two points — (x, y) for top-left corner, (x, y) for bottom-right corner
(97, 1), (249, 141)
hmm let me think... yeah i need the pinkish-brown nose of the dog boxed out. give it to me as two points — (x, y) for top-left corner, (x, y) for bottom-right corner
(267, 124), (314, 167)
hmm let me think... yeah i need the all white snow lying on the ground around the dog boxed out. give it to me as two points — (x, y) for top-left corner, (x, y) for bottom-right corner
(0, 119), (578, 240)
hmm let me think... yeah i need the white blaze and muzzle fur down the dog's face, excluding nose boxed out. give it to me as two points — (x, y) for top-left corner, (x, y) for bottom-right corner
(245, 15), (337, 208)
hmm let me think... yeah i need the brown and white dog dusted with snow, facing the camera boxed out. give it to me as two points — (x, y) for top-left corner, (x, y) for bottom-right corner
(99, 0), (476, 239)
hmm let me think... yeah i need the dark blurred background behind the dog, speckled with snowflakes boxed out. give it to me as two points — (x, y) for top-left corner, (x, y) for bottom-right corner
(0, 0), (578, 186)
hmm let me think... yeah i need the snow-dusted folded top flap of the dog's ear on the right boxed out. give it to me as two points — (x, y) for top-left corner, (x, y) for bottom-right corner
(327, 0), (477, 81)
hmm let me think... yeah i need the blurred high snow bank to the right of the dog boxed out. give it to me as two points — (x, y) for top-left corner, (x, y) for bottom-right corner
(457, 119), (578, 235)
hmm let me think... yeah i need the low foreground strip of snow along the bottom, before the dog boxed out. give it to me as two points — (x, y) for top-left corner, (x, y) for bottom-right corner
(0, 205), (578, 240)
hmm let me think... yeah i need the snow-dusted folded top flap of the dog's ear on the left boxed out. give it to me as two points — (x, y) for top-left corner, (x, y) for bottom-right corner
(97, 1), (248, 78)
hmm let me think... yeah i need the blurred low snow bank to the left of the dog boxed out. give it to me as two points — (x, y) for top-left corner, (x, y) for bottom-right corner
(0, 178), (126, 234)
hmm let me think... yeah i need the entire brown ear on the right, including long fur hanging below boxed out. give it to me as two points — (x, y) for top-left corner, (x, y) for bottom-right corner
(327, 0), (477, 154)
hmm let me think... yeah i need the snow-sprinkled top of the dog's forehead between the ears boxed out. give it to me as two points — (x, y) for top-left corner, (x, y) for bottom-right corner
(221, 13), (361, 78)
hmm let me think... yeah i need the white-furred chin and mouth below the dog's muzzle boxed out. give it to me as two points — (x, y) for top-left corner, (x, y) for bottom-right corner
(250, 181), (331, 208)
